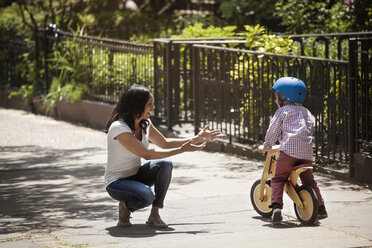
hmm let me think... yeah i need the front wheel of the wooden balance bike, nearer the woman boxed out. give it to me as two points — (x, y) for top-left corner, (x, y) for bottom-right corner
(251, 180), (273, 217)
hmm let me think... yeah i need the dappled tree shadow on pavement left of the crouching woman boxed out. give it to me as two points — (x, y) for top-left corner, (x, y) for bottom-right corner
(0, 146), (116, 234)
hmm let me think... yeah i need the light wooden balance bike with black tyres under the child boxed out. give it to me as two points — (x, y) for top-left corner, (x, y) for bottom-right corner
(251, 146), (318, 225)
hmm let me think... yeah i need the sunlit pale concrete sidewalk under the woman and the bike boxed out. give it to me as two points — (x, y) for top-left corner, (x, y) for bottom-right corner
(0, 108), (372, 248)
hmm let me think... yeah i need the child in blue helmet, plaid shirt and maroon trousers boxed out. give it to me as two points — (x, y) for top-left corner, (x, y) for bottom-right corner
(258, 77), (328, 223)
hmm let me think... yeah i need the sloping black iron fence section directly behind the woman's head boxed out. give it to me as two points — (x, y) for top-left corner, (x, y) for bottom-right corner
(35, 27), (154, 102)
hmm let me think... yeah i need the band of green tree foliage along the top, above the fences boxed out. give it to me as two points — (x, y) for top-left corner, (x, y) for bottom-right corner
(0, 0), (372, 42)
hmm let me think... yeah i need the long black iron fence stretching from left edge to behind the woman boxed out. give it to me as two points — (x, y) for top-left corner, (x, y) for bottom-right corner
(0, 25), (154, 102)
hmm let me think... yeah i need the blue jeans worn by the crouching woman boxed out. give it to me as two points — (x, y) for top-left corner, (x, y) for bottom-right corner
(106, 159), (173, 212)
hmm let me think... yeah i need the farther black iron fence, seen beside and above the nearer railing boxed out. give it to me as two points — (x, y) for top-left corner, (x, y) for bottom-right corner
(154, 32), (372, 129)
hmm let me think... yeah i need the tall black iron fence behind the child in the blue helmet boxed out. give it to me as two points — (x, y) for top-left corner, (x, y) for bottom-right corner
(154, 32), (372, 176)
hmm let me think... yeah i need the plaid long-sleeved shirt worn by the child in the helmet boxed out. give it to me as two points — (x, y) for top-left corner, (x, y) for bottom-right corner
(264, 105), (314, 160)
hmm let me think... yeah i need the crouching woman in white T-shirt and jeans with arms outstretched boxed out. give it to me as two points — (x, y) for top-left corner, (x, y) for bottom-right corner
(105, 85), (221, 228)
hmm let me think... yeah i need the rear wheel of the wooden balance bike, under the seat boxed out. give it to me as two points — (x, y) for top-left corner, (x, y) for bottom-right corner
(294, 185), (318, 226)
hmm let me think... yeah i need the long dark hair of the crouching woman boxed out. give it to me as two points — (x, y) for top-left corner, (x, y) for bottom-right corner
(104, 85), (150, 133)
